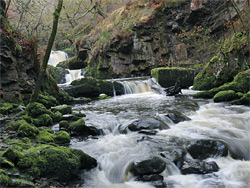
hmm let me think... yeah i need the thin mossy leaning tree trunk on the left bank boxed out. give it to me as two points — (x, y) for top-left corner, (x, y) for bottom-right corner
(30, 0), (63, 102)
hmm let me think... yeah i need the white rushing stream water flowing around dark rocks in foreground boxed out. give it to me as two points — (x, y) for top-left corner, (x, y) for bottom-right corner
(67, 82), (250, 188)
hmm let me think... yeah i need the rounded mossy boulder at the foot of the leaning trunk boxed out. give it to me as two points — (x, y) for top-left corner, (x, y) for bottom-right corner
(26, 102), (53, 117)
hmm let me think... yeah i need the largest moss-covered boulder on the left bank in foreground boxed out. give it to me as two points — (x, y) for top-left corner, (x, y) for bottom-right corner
(17, 145), (96, 181)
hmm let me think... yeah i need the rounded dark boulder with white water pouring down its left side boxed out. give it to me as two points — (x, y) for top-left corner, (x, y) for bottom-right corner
(131, 157), (166, 177)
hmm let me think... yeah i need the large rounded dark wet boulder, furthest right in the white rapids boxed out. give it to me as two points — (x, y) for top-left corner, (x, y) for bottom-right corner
(187, 140), (228, 160)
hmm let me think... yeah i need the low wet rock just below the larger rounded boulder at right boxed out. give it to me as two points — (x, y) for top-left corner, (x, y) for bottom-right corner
(180, 159), (219, 175)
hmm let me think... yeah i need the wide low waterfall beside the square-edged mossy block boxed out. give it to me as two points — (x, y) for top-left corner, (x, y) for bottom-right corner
(119, 78), (165, 94)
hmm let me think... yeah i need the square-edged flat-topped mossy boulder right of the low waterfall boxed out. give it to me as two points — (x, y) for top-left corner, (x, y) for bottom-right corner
(151, 67), (194, 88)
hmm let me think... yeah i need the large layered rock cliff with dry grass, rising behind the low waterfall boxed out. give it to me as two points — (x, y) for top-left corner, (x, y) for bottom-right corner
(75, 0), (235, 78)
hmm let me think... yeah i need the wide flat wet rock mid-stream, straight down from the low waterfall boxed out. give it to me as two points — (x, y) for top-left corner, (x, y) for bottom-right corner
(128, 118), (169, 131)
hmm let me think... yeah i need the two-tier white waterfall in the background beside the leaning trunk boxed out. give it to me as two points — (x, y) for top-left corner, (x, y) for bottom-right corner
(48, 51), (84, 85)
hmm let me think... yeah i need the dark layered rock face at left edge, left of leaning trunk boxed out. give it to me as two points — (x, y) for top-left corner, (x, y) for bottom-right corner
(0, 0), (38, 102)
